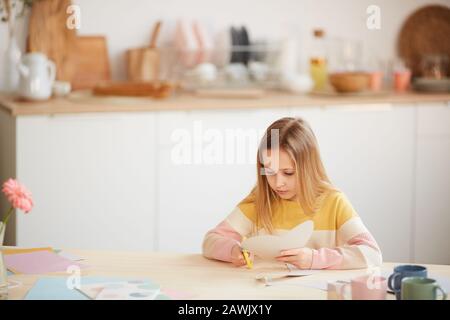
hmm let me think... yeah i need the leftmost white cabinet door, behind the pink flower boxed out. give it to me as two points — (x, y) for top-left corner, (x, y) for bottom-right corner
(17, 113), (157, 250)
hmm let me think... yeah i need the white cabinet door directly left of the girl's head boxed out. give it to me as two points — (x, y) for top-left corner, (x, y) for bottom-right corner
(157, 108), (288, 252)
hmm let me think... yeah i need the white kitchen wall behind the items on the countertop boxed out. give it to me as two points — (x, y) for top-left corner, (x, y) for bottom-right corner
(0, 0), (450, 84)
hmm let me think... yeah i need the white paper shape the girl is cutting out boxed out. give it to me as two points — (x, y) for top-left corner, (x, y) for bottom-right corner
(242, 220), (314, 259)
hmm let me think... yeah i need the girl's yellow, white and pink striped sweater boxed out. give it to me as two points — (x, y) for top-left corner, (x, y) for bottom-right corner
(203, 191), (382, 269)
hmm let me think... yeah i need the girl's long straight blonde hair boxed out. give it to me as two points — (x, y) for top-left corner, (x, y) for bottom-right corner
(243, 117), (335, 233)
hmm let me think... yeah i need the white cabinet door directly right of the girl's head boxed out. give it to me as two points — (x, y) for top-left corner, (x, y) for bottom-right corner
(292, 105), (414, 261)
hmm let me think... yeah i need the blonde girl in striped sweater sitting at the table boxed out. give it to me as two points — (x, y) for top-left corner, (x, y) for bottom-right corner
(203, 118), (382, 269)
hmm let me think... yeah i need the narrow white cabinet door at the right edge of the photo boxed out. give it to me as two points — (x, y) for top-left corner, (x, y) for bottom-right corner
(414, 104), (450, 264)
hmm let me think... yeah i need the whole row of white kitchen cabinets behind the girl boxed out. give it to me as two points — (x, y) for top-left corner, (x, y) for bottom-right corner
(0, 99), (450, 264)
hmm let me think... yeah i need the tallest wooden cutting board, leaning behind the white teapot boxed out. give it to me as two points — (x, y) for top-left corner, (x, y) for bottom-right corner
(26, 0), (76, 81)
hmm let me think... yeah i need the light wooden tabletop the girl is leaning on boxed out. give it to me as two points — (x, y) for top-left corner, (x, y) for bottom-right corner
(8, 250), (450, 300)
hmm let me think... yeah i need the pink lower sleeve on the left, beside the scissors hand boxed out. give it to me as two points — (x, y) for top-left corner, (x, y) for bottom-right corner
(203, 221), (242, 262)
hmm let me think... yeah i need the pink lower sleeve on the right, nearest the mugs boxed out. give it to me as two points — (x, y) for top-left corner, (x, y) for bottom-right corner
(311, 232), (381, 269)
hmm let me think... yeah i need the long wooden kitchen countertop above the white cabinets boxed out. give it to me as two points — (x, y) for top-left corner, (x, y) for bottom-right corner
(0, 91), (450, 116)
